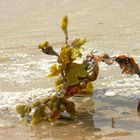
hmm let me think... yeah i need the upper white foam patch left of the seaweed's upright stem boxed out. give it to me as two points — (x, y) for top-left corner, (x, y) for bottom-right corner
(0, 56), (56, 84)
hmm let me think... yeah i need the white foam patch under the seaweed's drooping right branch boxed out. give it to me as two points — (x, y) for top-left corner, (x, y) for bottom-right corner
(101, 75), (140, 98)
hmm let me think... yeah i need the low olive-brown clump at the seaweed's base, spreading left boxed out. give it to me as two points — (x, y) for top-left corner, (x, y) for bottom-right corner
(16, 95), (76, 125)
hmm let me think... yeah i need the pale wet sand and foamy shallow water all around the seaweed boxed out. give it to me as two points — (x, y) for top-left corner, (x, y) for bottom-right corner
(0, 0), (140, 140)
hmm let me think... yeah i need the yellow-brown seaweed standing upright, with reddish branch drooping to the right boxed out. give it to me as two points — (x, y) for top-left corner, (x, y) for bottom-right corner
(16, 16), (140, 125)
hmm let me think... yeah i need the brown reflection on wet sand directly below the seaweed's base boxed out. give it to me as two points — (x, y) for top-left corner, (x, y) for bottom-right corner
(33, 114), (94, 140)
